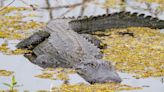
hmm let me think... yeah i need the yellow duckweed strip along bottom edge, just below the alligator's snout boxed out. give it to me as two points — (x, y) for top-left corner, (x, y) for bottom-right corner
(51, 83), (142, 92)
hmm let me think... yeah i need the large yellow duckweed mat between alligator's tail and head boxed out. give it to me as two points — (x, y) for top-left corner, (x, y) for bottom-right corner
(95, 27), (164, 78)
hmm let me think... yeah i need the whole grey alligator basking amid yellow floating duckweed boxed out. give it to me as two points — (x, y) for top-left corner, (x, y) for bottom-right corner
(17, 12), (164, 84)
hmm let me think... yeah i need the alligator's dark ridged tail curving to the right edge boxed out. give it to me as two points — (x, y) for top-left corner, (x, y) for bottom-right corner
(69, 12), (164, 33)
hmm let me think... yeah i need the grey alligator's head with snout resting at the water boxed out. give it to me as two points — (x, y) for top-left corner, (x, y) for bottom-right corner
(75, 59), (122, 84)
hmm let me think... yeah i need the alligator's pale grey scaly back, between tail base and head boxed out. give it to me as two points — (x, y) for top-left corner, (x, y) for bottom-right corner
(45, 19), (101, 58)
